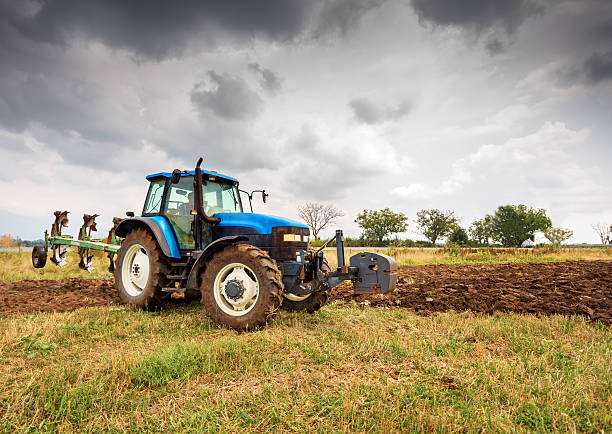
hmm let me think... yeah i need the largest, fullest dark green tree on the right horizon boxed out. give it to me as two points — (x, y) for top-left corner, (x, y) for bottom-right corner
(491, 205), (552, 247)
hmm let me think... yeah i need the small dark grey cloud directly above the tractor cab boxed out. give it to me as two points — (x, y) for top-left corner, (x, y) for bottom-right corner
(190, 71), (263, 120)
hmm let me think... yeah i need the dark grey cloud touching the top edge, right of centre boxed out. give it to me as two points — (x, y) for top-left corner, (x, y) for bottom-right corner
(412, 0), (544, 34)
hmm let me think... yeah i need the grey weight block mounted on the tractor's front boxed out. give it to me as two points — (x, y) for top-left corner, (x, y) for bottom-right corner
(349, 252), (397, 294)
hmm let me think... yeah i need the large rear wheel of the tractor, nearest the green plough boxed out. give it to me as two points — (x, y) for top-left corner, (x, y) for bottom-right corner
(114, 229), (168, 309)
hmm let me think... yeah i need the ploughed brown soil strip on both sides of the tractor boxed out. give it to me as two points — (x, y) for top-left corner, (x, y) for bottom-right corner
(0, 261), (612, 324)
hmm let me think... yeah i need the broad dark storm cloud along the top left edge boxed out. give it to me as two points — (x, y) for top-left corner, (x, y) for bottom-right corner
(10, 0), (313, 59)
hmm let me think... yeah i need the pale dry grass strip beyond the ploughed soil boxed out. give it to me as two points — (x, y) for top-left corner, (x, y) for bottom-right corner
(0, 247), (612, 282)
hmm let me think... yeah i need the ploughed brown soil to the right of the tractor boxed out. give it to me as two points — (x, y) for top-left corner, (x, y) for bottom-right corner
(332, 261), (612, 324)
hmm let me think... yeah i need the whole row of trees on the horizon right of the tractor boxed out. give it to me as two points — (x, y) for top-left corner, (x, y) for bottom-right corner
(298, 203), (612, 248)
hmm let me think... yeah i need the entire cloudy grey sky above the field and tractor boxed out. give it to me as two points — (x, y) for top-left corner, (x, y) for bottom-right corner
(0, 0), (612, 243)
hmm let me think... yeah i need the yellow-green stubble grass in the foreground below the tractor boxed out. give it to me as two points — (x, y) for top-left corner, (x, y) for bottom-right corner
(0, 304), (612, 432)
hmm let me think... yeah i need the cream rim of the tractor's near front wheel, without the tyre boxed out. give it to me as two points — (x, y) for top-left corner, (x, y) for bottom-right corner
(213, 262), (259, 316)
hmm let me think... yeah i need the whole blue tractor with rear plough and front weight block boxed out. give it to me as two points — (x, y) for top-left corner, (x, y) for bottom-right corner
(32, 158), (397, 331)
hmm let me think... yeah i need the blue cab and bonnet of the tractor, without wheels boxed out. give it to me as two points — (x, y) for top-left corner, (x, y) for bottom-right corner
(139, 159), (310, 262)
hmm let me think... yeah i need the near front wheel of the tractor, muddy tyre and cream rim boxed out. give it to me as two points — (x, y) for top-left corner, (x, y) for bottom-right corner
(200, 244), (283, 331)
